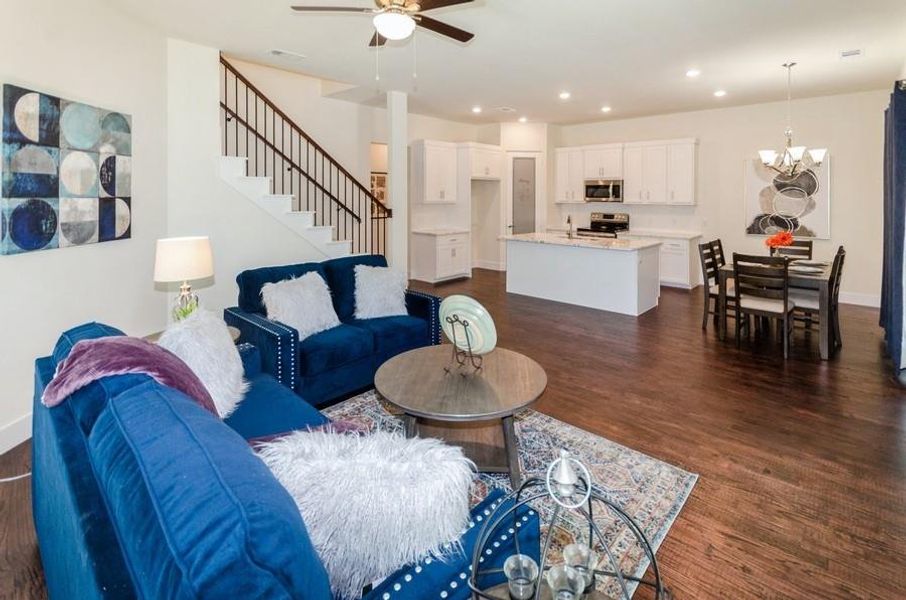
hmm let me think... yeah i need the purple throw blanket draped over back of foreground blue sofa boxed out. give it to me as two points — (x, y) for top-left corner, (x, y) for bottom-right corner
(41, 336), (220, 419)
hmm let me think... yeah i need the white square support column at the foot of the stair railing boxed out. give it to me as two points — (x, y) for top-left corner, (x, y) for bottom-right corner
(387, 91), (409, 273)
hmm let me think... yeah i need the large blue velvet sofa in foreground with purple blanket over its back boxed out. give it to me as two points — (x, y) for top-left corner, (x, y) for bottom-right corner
(32, 323), (539, 600)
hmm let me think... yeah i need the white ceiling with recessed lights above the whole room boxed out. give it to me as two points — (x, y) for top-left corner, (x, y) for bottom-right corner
(108, 0), (906, 123)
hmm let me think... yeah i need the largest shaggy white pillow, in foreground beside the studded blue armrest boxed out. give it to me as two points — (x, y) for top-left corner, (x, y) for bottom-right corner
(256, 431), (474, 599)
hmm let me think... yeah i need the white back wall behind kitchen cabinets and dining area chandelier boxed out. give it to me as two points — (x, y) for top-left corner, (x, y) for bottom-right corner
(549, 90), (889, 304)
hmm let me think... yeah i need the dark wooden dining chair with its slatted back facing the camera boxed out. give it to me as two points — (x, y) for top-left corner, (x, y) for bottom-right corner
(733, 252), (796, 359)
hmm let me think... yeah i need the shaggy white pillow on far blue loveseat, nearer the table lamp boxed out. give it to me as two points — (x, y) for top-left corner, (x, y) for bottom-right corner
(261, 272), (340, 342)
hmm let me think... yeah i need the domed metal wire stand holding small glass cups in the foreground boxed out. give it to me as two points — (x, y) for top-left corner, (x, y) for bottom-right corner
(469, 450), (670, 600)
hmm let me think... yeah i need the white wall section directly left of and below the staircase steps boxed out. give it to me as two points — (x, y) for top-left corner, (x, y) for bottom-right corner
(166, 40), (328, 313)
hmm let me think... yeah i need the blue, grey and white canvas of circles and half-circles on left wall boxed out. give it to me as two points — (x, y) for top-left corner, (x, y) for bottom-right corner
(0, 84), (132, 254)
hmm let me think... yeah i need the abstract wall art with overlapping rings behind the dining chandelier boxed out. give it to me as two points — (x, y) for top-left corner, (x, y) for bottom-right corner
(745, 156), (830, 240)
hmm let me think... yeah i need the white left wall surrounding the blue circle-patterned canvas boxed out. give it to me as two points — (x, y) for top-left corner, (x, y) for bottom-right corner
(0, 0), (167, 453)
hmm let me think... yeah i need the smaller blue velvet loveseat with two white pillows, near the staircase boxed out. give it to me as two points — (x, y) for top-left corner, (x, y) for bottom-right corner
(224, 255), (440, 406)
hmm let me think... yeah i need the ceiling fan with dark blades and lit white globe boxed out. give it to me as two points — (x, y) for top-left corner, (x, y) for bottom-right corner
(291, 0), (475, 46)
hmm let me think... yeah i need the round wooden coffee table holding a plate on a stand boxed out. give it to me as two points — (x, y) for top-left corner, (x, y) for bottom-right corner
(374, 344), (547, 487)
